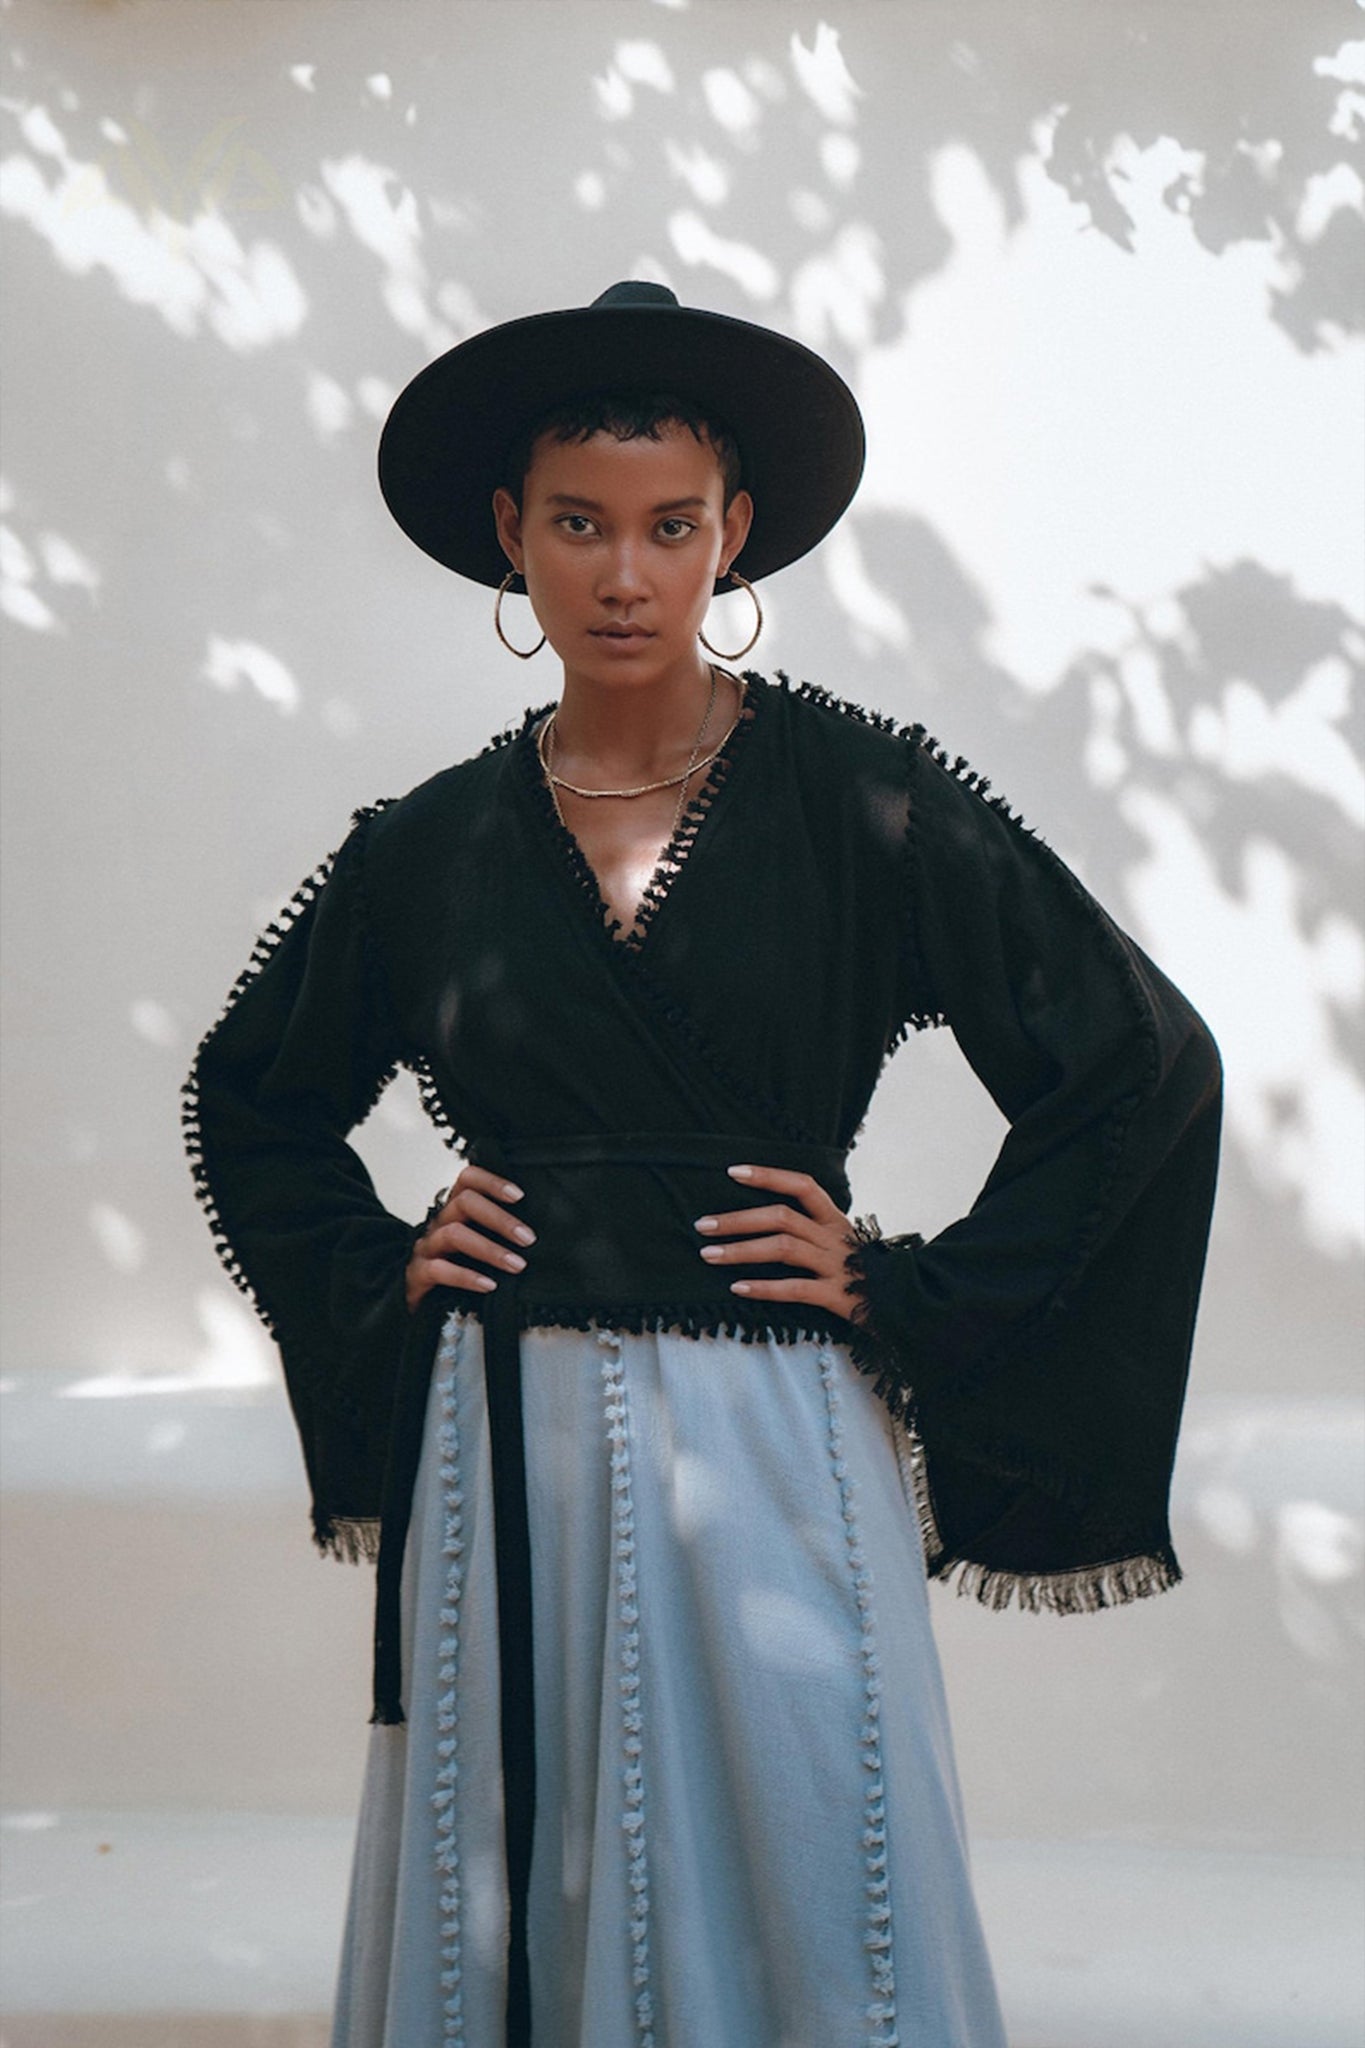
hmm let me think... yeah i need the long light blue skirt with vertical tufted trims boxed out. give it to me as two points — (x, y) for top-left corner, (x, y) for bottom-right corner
(334, 1317), (1005, 2048)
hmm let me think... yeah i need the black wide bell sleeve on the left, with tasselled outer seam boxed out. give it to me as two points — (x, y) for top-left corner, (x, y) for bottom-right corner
(182, 813), (413, 1559)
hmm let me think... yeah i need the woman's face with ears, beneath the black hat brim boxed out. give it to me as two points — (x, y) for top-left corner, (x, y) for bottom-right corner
(493, 424), (753, 686)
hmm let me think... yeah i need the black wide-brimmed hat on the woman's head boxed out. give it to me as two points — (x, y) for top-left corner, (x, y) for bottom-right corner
(379, 283), (864, 588)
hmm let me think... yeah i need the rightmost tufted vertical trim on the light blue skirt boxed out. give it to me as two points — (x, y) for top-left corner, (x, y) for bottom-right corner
(819, 1348), (900, 2048)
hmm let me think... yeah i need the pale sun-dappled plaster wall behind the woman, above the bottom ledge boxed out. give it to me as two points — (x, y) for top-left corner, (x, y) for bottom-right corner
(0, 0), (1365, 1966)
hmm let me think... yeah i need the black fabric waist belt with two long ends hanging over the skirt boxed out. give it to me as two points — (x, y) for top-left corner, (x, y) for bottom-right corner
(375, 1130), (849, 2048)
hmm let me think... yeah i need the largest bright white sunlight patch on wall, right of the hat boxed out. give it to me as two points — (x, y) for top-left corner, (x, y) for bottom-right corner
(860, 131), (1361, 692)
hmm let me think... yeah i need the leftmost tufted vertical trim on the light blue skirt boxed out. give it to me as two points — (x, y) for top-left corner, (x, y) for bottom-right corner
(432, 1325), (465, 2048)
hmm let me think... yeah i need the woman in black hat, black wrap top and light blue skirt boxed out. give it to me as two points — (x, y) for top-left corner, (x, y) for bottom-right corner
(188, 285), (1220, 2048)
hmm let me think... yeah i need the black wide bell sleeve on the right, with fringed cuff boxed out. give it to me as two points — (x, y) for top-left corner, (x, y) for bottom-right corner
(851, 739), (1222, 1612)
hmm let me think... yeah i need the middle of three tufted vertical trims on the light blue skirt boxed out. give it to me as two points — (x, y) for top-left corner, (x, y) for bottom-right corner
(598, 1329), (655, 2048)
